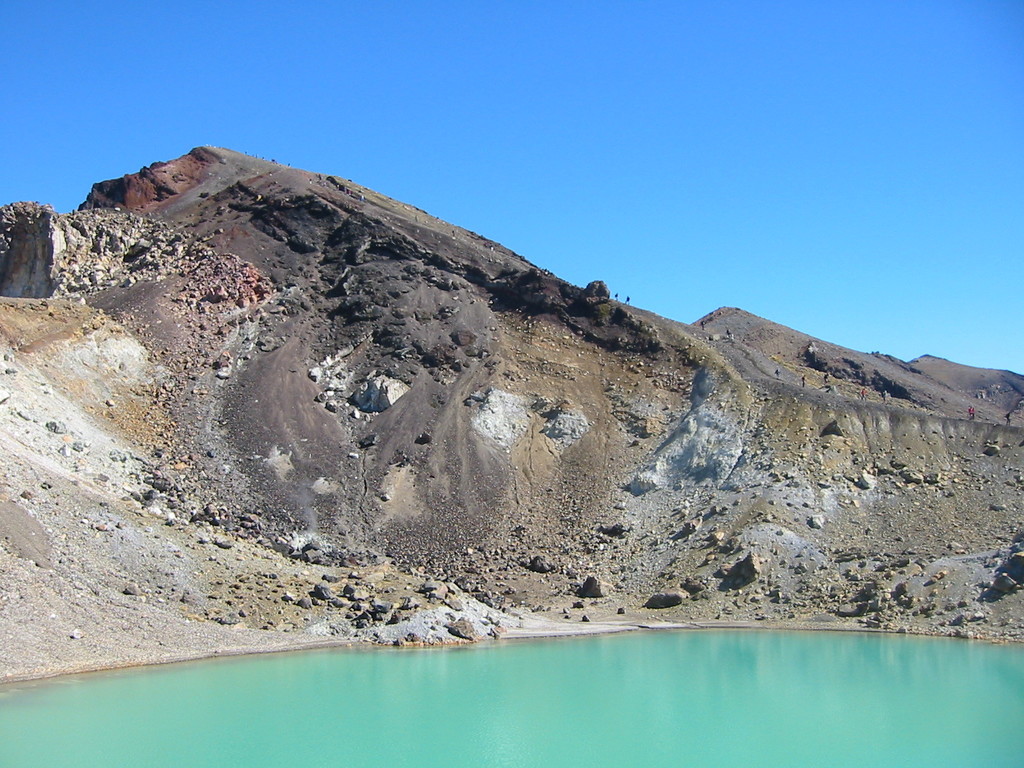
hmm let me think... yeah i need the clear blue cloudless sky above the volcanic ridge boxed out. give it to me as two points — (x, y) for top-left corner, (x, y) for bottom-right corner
(0, 0), (1024, 373)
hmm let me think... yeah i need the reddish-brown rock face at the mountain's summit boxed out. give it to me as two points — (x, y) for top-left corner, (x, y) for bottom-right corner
(81, 146), (217, 212)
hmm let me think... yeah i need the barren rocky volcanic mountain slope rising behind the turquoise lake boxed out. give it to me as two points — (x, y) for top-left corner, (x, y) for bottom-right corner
(0, 147), (1024, 674)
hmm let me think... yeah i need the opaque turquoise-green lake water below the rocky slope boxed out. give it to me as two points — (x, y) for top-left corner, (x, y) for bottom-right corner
(0, 631), (1024, 768)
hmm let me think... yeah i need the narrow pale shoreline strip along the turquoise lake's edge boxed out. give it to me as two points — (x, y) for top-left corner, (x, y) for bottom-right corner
(6, 615), (1024, 694)
